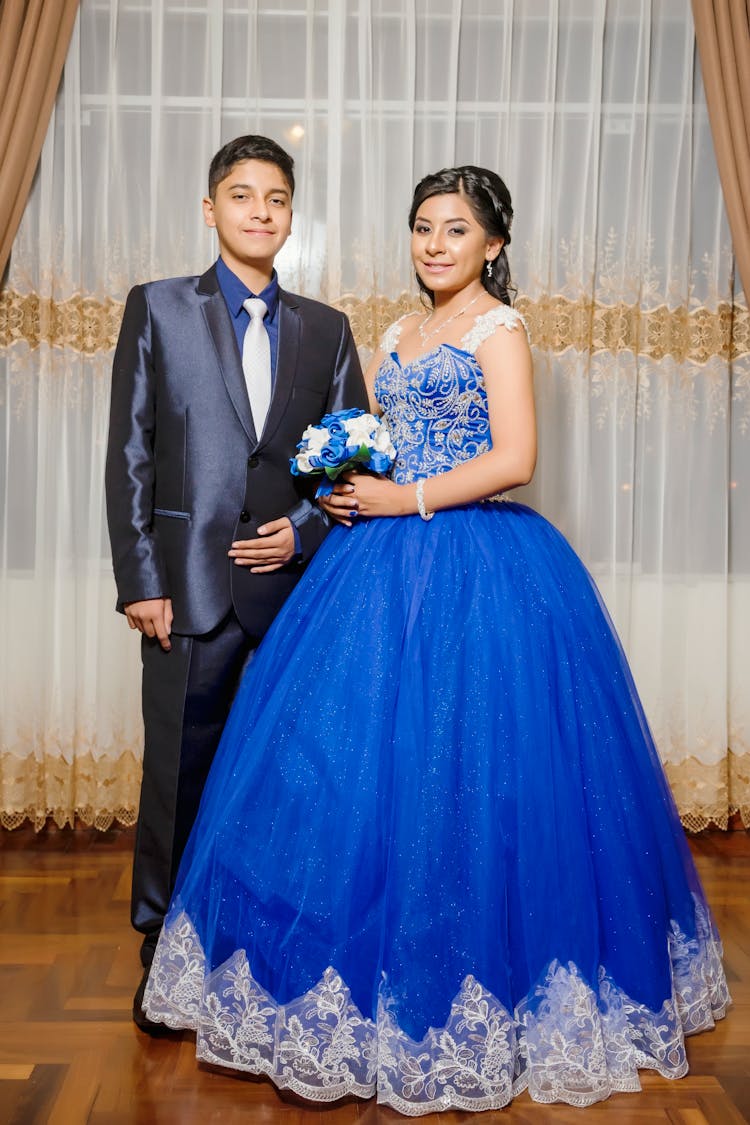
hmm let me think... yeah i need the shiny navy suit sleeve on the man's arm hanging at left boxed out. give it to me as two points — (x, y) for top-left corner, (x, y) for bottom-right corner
(105, 286), (169, 611)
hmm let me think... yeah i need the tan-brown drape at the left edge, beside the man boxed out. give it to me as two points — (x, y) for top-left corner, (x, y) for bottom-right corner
(0, 0), (79, 277)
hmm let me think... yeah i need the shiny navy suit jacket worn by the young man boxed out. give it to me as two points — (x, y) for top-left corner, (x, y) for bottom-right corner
(106, 258), (367, 637)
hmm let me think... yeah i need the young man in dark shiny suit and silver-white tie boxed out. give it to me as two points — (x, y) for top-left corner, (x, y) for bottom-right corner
(106, 136), (367, 1031)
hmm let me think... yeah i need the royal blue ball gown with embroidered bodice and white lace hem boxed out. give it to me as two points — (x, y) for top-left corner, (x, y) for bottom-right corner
(144, 307), (729, 1116)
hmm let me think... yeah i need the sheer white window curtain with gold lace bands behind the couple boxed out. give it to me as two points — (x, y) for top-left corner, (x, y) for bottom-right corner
(0, 0), (750, 827)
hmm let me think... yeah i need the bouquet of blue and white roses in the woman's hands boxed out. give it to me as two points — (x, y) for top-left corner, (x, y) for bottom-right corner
(289, 408), (396, 497)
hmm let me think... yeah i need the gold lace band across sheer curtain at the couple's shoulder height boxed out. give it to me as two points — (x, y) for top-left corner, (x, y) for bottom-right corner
(0, 289), (750, 363)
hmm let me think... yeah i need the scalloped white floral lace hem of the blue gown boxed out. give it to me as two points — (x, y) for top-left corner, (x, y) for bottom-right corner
(144, 901), (730, 1117)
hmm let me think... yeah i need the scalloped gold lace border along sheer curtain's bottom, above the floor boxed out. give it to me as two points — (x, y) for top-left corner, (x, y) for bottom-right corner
(0, 750), (750, 833)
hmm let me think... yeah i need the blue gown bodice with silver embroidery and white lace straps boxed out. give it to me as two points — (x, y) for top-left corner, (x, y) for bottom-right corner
(374, 305), (525, 484)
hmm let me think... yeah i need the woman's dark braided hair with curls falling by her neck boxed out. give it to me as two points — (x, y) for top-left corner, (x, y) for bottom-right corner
(409, 164), (516, 305)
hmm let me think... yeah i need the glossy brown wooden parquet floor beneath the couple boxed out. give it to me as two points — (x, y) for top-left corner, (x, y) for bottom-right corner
(0, 828), (750, 1125)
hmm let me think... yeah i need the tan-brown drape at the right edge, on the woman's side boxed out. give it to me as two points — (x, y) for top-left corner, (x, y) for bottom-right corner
(693, 0), (750, 297)
